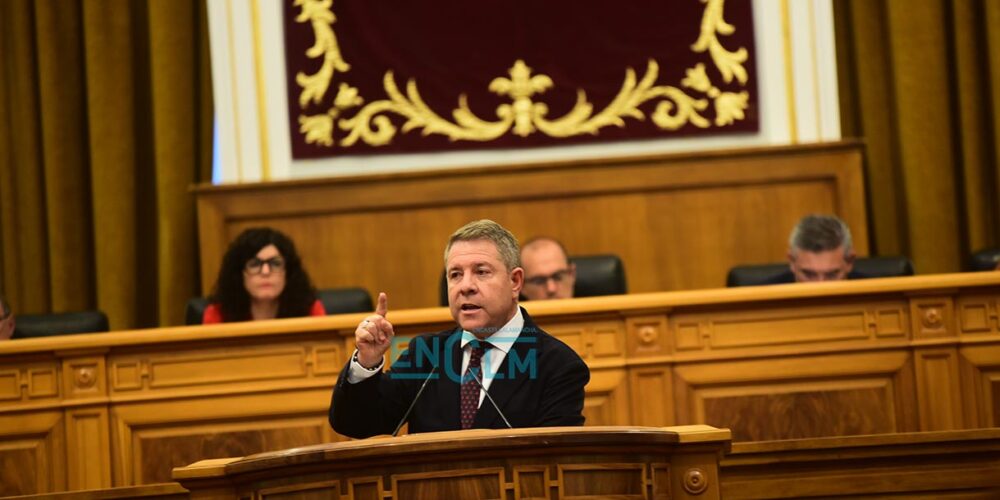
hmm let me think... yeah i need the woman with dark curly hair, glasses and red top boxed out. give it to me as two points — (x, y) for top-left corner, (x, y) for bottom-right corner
(202, 227), (326, 324)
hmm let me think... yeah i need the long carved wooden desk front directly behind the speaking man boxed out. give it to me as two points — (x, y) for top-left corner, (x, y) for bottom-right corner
(0, 273), (1000, 495)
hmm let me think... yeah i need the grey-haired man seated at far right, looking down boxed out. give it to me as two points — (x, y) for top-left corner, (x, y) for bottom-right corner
(765, 214), (866, 284)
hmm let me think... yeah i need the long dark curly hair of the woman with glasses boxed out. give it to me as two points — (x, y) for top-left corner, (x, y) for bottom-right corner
(209, 227), (316, 322)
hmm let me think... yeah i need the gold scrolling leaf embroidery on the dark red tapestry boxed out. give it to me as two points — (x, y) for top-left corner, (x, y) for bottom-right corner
(295, 0), (750, 147)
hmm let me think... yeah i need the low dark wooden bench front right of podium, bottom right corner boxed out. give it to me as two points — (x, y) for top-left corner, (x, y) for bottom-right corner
(721, 429), (1000, 499)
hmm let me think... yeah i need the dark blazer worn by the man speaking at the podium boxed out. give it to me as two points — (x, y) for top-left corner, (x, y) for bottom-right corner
(330, 309), (590, 438)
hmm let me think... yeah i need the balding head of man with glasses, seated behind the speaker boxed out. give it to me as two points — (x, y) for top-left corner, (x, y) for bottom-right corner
(521, 241), (576, 300)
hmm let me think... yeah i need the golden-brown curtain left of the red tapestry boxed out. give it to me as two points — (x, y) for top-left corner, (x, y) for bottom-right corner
(0, 0), (212, 329)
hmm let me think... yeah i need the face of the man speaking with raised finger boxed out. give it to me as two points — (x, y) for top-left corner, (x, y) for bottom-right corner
(445, 240), (524, 336)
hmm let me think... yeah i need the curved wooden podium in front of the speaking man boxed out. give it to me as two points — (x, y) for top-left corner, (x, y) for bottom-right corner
(173, 425), (730, 500)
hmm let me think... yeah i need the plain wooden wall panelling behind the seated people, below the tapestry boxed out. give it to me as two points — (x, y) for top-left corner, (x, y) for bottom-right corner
(195, 143), (868, 308)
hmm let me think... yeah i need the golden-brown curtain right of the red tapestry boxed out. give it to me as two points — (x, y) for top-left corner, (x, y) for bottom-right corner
(834, 0), (1000, 273)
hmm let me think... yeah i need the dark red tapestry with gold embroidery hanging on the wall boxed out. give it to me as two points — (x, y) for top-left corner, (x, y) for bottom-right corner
(284, 0), (759, 158)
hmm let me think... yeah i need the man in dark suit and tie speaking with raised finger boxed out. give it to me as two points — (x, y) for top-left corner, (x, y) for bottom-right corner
(330, 220), (590, 438)
